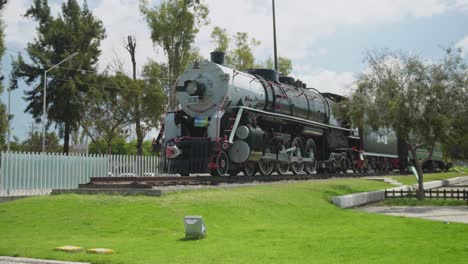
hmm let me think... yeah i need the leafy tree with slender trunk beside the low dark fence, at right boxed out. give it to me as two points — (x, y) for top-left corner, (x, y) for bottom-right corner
(343, 49), (468, 199)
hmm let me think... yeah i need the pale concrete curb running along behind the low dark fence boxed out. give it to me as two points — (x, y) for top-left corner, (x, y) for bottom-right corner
(332, 177), (468, 208)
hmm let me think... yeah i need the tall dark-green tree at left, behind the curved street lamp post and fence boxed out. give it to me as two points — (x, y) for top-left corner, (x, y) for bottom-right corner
(13, 0), (105, 153)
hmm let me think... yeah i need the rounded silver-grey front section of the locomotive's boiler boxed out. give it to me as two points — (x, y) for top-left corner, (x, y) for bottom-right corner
(176, 61), (265, 117)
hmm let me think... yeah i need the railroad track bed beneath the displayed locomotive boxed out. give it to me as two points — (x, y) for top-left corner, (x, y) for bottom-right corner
(79, 173), (388, 189)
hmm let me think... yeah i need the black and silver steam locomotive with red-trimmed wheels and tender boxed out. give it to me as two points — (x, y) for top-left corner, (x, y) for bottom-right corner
(154, 52), (446, 176)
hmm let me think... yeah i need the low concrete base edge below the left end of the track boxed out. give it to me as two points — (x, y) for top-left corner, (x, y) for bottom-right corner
(51, 188), (162, 196)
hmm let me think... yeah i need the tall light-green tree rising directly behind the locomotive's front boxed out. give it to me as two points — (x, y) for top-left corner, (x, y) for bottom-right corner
(140, 0), (209, 109)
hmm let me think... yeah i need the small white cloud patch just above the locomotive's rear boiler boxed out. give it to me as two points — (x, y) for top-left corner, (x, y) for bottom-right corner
(293, 65), (355, 95)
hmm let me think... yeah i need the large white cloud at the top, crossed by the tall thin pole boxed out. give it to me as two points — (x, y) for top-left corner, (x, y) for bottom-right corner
(197, 0), (450, 61)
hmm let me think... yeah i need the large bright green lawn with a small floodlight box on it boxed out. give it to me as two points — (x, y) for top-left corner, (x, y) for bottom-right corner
(0, 179), (468, 264)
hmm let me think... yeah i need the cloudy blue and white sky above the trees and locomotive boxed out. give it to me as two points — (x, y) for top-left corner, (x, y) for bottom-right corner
(1, 0), (468, 139)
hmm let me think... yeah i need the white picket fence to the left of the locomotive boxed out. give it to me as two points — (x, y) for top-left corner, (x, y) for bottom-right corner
(0, 152), (159, 196)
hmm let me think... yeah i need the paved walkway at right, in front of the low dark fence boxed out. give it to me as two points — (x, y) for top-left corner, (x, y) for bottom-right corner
(360, 206), (468, 224)
